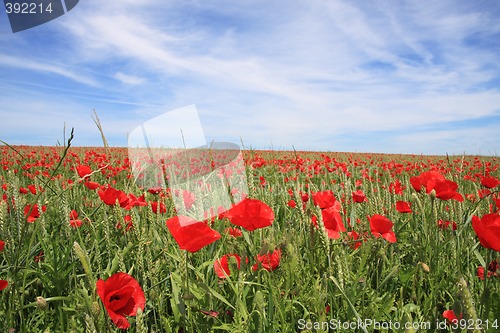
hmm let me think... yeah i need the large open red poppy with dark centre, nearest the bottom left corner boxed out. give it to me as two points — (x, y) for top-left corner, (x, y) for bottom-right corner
(96, 272), (146, 329)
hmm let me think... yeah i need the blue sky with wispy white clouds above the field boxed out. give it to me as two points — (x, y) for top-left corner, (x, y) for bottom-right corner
(0, 0), (500, 155)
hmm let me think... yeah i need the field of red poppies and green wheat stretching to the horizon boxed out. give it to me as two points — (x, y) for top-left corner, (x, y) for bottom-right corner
(0, 139), (500, 332)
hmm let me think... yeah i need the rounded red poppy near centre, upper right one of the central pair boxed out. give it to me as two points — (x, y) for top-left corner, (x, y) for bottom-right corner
(223, 198), (274, 231)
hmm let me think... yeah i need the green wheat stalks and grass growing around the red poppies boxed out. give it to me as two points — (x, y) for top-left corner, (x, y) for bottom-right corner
(0, 144), (500, 332)
